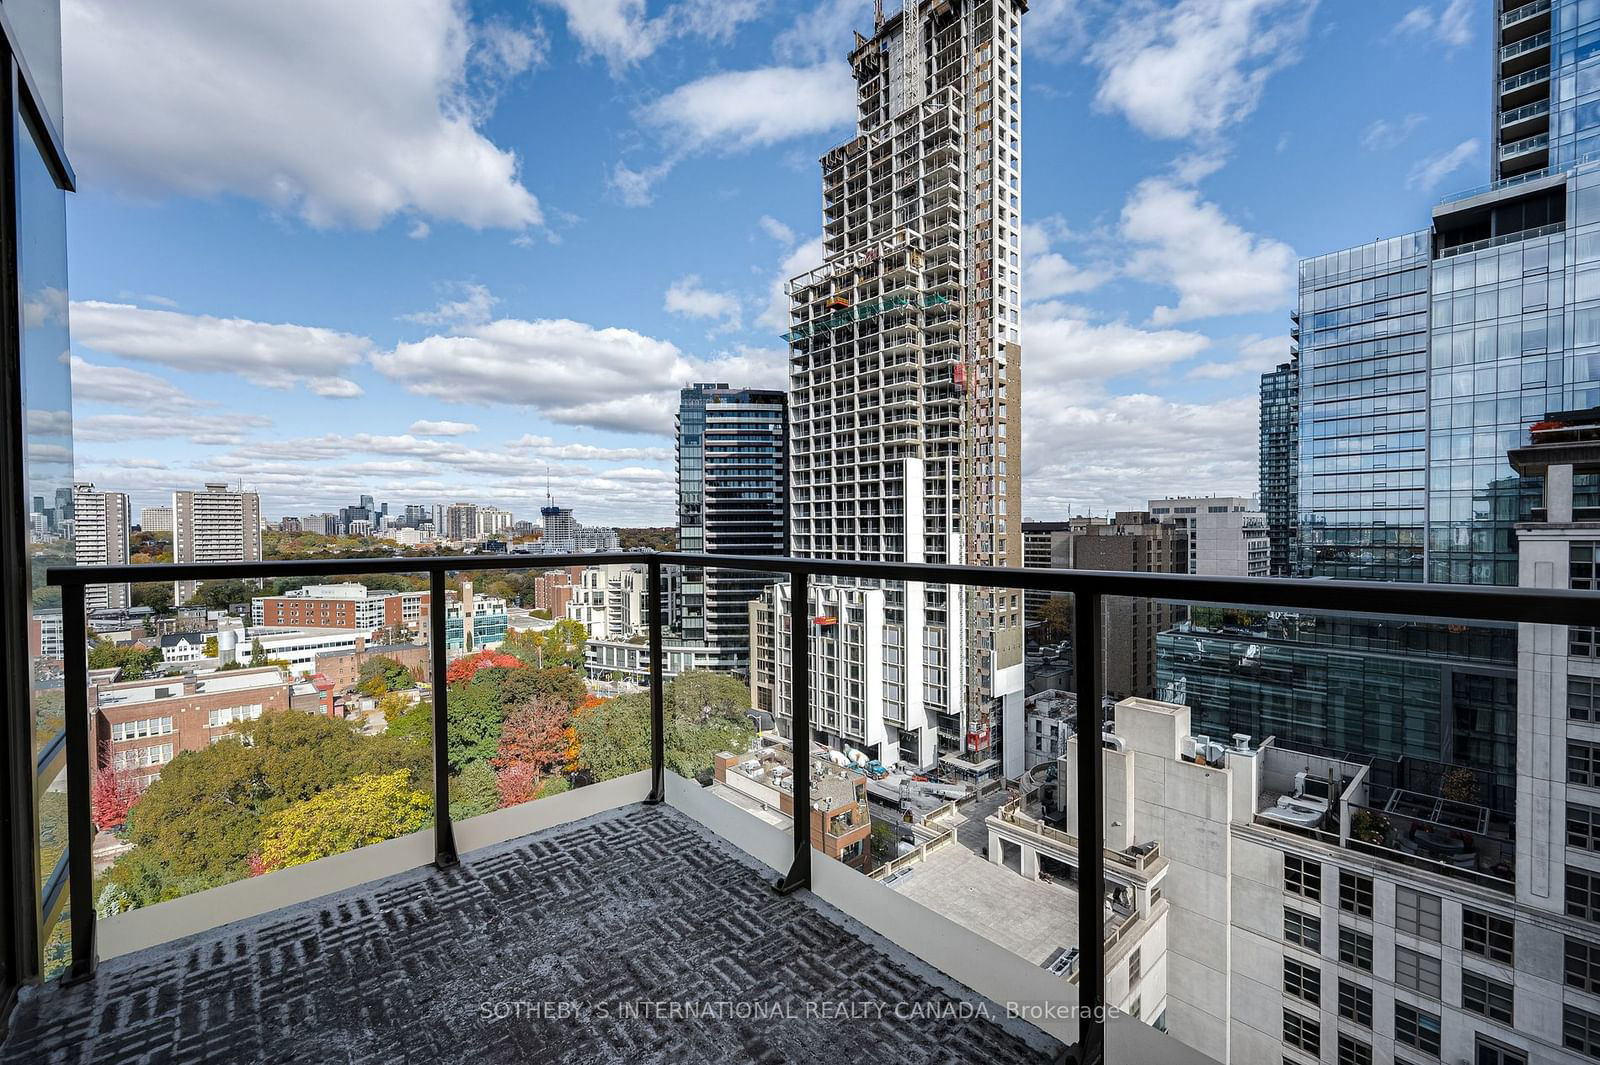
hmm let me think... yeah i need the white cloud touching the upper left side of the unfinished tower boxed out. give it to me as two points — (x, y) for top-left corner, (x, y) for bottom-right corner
(610, 62), (856, 206)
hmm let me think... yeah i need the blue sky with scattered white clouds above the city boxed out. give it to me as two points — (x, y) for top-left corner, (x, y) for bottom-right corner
(62, 0), (1491, 526)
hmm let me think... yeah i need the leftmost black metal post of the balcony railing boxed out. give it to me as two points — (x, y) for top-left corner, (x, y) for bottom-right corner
(61, 584), (96, 982)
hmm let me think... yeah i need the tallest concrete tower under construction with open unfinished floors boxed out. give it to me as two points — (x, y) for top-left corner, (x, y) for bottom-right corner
(752, 0), (1027, 779)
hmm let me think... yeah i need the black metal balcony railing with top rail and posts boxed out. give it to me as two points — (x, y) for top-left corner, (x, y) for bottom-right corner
(42, 552), (1600, 1065)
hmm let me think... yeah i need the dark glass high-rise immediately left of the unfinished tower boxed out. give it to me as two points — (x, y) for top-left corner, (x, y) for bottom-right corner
(677, 384), (789, 668)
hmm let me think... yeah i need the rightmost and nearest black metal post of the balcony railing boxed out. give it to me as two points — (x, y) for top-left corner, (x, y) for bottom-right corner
(1072, 590), (1106, 1065)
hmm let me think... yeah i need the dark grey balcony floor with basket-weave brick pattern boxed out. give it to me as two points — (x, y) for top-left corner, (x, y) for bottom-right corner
(9, 804), (1061, 1065)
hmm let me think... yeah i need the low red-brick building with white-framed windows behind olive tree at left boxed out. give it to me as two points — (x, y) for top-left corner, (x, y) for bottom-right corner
(90, 665), (291, 785)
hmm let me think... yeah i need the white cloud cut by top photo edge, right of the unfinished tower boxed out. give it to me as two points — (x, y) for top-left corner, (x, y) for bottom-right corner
(1088, 0), (1317, 139)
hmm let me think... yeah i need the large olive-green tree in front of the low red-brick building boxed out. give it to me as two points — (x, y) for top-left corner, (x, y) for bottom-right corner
(107, 710), (429, 905)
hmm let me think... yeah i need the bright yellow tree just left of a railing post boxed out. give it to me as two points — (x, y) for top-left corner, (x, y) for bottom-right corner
(261, 769), (434, 870)
